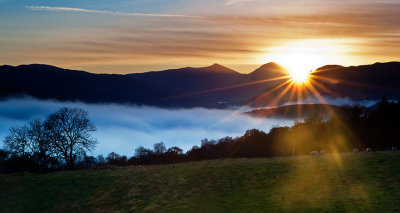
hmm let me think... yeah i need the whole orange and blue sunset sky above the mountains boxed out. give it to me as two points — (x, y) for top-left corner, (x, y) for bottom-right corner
(0, 0), (400, 73)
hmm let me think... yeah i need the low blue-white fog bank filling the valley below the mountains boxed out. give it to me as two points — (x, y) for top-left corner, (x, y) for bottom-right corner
(0, 98), (293, 156)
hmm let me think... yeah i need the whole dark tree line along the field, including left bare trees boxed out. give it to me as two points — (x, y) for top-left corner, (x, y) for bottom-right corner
(0, 97), (400, 172)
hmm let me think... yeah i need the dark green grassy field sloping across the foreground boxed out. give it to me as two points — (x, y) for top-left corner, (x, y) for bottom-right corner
(0, 152), (400, 212)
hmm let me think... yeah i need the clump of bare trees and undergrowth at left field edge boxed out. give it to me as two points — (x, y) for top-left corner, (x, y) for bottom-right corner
(0, 107), (97, 172)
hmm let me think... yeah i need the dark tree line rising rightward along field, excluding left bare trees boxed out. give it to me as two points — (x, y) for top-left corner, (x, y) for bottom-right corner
(116, 96), (400, 165)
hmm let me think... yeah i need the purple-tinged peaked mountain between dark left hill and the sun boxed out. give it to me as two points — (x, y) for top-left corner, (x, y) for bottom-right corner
(128, 64), (285, 108)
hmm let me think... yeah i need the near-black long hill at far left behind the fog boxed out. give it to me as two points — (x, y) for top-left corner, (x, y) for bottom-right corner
(0, 64), (167, 103)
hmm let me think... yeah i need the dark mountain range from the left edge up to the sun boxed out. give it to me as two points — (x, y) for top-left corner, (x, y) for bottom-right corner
(0, 64), (288, 108)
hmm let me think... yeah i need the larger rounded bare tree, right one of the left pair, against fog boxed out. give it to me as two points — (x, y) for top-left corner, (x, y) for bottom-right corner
(44, 107), (97, 169)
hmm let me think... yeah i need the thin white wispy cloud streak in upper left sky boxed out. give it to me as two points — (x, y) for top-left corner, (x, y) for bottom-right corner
(25, 6), (202, 18)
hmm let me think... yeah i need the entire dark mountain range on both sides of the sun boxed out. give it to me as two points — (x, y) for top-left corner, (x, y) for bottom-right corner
(0, 62), (400, 108)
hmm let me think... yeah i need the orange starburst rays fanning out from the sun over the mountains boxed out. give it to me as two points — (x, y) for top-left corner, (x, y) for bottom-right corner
(143, 57), (384, 141)
